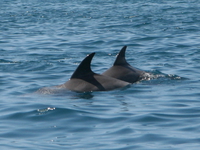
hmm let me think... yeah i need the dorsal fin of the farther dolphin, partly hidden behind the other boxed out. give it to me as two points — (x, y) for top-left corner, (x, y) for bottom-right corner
(113, 46), (129, 66)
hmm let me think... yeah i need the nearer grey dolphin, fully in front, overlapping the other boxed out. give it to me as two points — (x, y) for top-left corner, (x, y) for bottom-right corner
(58, 53), (130, 92)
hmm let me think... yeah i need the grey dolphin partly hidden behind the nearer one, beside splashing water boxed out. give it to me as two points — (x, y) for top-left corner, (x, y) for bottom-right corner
(102, 46), (146, 83)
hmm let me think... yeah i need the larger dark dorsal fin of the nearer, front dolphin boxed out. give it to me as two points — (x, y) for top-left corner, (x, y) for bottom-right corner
(71, 53), (95, 79)
